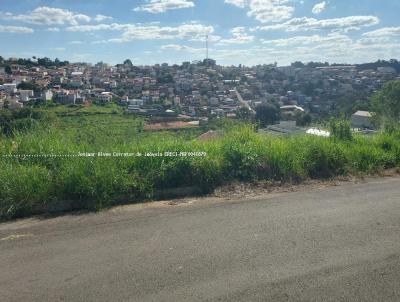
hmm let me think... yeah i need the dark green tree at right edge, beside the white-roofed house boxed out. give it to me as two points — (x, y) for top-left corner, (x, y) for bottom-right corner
(370, 81), (400, 123)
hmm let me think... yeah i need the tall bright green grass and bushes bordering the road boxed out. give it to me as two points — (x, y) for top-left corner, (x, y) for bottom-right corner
(0, 112), (400, 219)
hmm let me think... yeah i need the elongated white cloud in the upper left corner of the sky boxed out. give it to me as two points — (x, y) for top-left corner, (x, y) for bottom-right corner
(1, 6), (91, 25)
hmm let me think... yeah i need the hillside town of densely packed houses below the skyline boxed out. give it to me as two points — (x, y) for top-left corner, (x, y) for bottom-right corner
(0, 58), (400, 127)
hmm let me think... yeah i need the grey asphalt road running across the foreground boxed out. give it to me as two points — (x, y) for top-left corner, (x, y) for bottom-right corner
(0, 177), (400, 302)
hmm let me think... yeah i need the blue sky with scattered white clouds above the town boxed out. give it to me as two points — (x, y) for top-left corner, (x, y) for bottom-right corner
(0, 0), (400, 66)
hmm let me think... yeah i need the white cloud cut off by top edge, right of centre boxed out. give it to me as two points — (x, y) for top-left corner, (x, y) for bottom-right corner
(225, 0), (294, 23)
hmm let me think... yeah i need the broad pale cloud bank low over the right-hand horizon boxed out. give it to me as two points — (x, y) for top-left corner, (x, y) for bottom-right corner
(213, 34), (400, 65)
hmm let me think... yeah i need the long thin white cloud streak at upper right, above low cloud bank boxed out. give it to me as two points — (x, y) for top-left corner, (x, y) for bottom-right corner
(254, 16), (379, 32)
